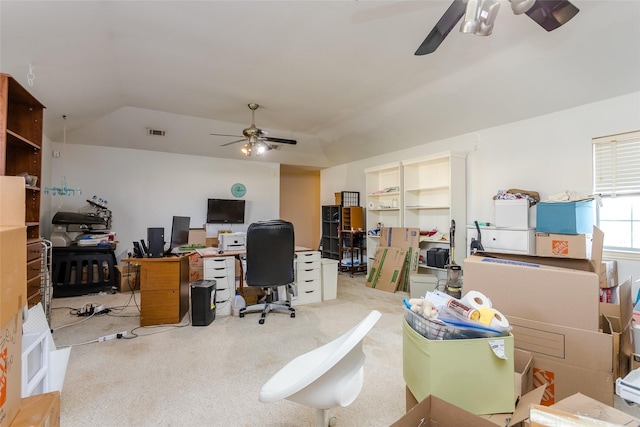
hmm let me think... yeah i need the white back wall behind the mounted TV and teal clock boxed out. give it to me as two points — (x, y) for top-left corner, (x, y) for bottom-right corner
(41, 142), (280, 259)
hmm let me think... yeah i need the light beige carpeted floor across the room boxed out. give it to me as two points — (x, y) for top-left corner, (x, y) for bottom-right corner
(51, 273), (407, 427)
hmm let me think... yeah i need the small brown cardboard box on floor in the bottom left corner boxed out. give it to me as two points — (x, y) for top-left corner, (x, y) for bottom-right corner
(11, 391), (60, 427)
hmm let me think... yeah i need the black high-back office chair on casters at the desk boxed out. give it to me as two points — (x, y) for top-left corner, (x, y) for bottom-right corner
(239, 219), (296, 324)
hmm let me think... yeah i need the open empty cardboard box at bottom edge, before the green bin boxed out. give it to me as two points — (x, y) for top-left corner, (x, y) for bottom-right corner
(391, 389), (495, 427)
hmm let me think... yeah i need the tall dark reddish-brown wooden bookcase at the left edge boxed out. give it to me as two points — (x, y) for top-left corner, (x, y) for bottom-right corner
(0, 74), (45, 307)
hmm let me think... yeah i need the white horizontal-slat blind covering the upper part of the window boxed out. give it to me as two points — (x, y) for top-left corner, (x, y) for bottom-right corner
(592, 131), (640, 197)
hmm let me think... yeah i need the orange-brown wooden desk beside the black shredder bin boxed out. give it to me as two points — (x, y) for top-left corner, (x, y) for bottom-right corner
(122, 255), (189, 326)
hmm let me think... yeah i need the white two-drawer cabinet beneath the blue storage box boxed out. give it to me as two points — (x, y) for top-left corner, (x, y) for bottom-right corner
(467, 227), (536, 254)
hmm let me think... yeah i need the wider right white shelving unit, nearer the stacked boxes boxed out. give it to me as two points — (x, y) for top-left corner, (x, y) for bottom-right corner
(402, 151), (467, 278)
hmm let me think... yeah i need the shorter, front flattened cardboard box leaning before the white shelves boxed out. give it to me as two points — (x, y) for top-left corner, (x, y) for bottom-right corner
(367, 246), (407, 292)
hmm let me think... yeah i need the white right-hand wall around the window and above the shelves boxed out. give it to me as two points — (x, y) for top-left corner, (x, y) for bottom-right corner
(321, 92), (640, 296)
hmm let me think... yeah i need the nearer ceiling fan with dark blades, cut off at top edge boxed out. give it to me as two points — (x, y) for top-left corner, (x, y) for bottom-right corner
(415, 0), (579, 55)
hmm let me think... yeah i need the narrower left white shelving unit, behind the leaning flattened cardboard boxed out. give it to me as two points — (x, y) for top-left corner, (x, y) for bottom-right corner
(364, 162), (402, 269)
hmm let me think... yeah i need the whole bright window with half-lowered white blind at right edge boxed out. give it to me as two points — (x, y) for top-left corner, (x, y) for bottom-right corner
(593, 131), (640, 255)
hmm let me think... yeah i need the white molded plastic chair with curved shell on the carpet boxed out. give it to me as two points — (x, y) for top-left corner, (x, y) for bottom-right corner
(260, 310), (382, 427)
